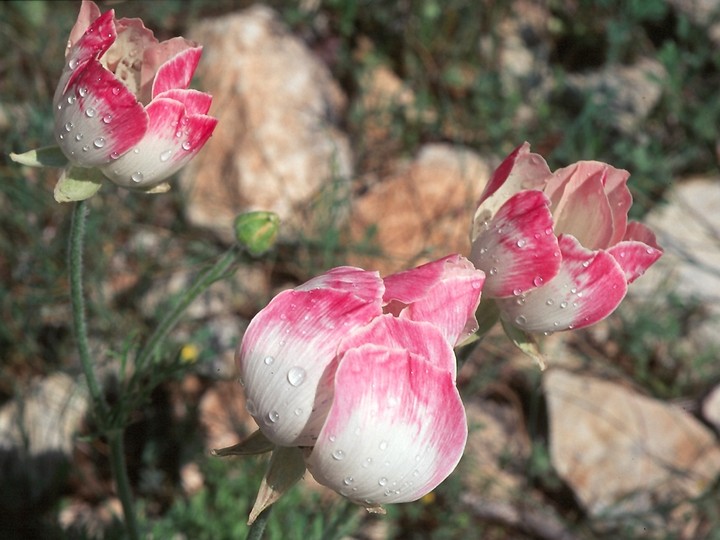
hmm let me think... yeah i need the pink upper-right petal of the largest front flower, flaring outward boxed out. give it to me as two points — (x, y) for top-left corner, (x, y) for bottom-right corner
(383, 255), (485, 345)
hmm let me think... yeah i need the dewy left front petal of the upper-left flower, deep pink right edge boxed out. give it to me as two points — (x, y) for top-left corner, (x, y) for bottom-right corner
(55, 60), (149, 167)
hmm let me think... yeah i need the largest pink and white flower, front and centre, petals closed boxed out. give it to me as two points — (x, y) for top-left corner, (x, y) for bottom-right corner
(237, 255), (484, 506)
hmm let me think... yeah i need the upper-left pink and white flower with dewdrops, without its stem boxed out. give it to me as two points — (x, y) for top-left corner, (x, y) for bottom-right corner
(53, 1), (217, 190)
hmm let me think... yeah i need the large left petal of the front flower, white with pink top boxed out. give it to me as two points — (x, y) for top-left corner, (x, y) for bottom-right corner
(236, 268), (382, 446)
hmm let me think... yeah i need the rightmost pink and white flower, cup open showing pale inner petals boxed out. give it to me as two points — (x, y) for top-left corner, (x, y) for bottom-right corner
(470, 143), (662, 332)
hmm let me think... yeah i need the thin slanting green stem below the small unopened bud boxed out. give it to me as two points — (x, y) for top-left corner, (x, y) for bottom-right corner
(136, 245), (242, 366)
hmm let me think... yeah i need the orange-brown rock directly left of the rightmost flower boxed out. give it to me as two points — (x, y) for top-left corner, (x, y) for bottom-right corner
(349, 144), (490, 274)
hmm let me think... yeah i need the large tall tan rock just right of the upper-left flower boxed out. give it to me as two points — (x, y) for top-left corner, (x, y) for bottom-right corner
(181, 5), (352, 240)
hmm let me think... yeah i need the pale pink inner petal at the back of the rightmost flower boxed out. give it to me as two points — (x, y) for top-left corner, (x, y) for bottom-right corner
(546, 161), (614, 249)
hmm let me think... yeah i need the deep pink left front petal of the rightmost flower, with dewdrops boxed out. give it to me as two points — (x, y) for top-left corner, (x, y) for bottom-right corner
(470, 190), (561, 298)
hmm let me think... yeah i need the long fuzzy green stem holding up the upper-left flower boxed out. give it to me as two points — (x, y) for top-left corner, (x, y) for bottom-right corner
(69, 201), (140, 540)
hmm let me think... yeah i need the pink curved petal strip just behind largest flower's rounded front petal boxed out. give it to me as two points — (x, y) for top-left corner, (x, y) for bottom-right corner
(338, 314), (457, 380)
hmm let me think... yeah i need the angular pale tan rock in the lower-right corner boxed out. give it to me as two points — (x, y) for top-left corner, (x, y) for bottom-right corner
(543, 368), (720, 525)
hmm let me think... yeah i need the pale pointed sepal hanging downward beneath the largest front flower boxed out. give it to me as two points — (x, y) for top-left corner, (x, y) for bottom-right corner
(248, 446), (306, 525)
